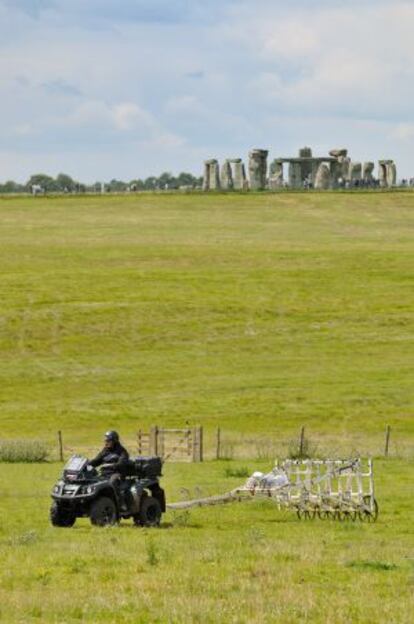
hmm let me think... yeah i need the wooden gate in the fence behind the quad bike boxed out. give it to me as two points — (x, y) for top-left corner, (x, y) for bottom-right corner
(137, 427), (203, 462)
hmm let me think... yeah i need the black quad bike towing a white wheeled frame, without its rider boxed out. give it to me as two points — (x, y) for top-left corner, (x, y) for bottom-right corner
(50, 455), (166, 527)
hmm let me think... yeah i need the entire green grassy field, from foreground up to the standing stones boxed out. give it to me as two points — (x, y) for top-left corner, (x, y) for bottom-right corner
(0, 192), (414, 624)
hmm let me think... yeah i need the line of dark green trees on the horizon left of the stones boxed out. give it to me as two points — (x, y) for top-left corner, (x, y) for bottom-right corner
(0, 172), (202, 194)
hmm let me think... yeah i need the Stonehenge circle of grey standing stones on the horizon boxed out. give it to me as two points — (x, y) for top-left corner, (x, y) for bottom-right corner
(203, 147), (397, 191)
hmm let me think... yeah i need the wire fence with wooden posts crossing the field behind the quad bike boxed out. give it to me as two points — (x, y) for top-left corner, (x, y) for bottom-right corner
(0, 426), (414, 462)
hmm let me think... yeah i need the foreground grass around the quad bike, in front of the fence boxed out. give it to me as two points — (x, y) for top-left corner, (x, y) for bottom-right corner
(0, 460), (414, 624)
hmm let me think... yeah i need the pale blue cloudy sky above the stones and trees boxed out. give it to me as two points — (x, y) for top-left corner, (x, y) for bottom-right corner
(0, 0), (414, 182)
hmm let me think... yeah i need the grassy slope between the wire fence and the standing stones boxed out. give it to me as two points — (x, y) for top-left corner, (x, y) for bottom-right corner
(0, 192), (414, 454)
